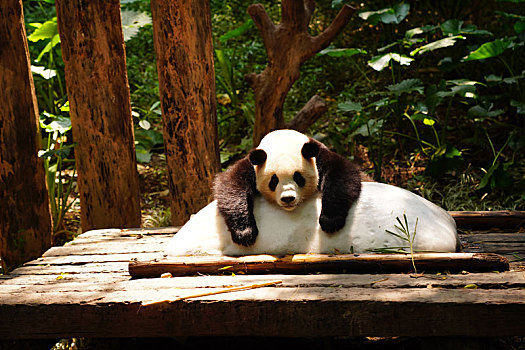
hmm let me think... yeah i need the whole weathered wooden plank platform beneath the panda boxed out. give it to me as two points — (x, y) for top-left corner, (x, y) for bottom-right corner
(0, 220), (525, 339)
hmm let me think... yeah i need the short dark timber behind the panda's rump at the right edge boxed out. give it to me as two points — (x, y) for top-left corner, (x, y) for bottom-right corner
(449, 210), (525, 228)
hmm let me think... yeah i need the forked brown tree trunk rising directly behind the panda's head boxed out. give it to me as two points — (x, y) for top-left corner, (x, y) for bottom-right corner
(246, 0), (354, 145)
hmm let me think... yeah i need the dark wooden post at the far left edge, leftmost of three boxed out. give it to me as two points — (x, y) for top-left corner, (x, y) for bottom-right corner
(0, 0), (52, 267)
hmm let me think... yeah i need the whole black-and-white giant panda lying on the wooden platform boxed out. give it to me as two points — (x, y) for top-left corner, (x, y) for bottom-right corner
(167, 130), (459, 256)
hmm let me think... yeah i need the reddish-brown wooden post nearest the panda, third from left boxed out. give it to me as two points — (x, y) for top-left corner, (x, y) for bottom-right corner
(151, 0), (220, 225)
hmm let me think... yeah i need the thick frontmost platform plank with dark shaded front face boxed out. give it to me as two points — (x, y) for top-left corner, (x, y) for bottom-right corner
(0, 287), (525, 338)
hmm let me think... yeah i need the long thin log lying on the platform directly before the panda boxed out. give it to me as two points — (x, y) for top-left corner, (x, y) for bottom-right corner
(129, 253), (509, 278)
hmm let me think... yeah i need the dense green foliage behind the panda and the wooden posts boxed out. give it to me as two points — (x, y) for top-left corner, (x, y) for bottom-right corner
(24, 0), (525, 232)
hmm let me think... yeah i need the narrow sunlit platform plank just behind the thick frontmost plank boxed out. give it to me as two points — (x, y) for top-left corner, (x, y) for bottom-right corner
(0, 272), (525, 292)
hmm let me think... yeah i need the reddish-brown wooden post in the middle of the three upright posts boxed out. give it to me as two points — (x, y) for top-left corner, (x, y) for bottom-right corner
(56, 0), (140, 231)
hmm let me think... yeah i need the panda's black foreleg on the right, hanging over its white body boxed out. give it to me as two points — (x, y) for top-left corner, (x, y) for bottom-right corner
(303, 139), (361, 233)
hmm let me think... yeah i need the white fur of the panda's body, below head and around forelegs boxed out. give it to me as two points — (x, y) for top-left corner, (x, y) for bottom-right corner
(167, 182), (458, 256)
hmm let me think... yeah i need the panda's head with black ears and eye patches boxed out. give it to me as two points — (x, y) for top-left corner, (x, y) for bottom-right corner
(249, 130), (319, 211)
